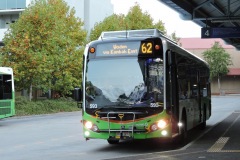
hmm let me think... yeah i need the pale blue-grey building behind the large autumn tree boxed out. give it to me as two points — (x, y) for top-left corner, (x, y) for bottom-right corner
(0, 0), (113, 46)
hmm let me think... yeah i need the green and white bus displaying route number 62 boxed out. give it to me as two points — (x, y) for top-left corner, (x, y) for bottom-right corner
(75, 29), (211, 144)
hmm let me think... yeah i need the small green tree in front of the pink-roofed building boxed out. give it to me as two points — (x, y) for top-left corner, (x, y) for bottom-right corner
(203, 42), (232, 92)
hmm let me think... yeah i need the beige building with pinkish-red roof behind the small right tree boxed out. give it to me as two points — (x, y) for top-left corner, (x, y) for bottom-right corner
(179, 38), (240, 95)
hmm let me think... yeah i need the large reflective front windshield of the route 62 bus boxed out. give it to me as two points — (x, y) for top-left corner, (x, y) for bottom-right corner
(85, 57), (163, 108)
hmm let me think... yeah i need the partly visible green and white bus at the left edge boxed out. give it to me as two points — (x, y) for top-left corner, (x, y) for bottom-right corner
(0, 67), (15, 119)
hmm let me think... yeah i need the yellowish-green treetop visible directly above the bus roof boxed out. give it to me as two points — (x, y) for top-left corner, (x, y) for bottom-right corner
(90, 3), (166, 41)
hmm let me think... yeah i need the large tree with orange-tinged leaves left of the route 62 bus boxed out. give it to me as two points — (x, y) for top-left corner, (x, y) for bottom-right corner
(2, 0), (86, 99)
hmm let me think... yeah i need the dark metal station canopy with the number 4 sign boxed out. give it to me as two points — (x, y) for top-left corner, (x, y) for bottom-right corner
(159, 0), (240, 50)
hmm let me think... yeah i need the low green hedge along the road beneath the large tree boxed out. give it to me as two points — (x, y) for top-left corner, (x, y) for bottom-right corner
(15, 96), (80, 116)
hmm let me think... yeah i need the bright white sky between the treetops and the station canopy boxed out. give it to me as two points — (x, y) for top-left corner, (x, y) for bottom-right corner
(111, 0), (201, 38)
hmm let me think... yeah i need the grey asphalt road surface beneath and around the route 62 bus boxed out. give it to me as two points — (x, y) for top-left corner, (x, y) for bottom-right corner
(0, 96), (240, 160)
